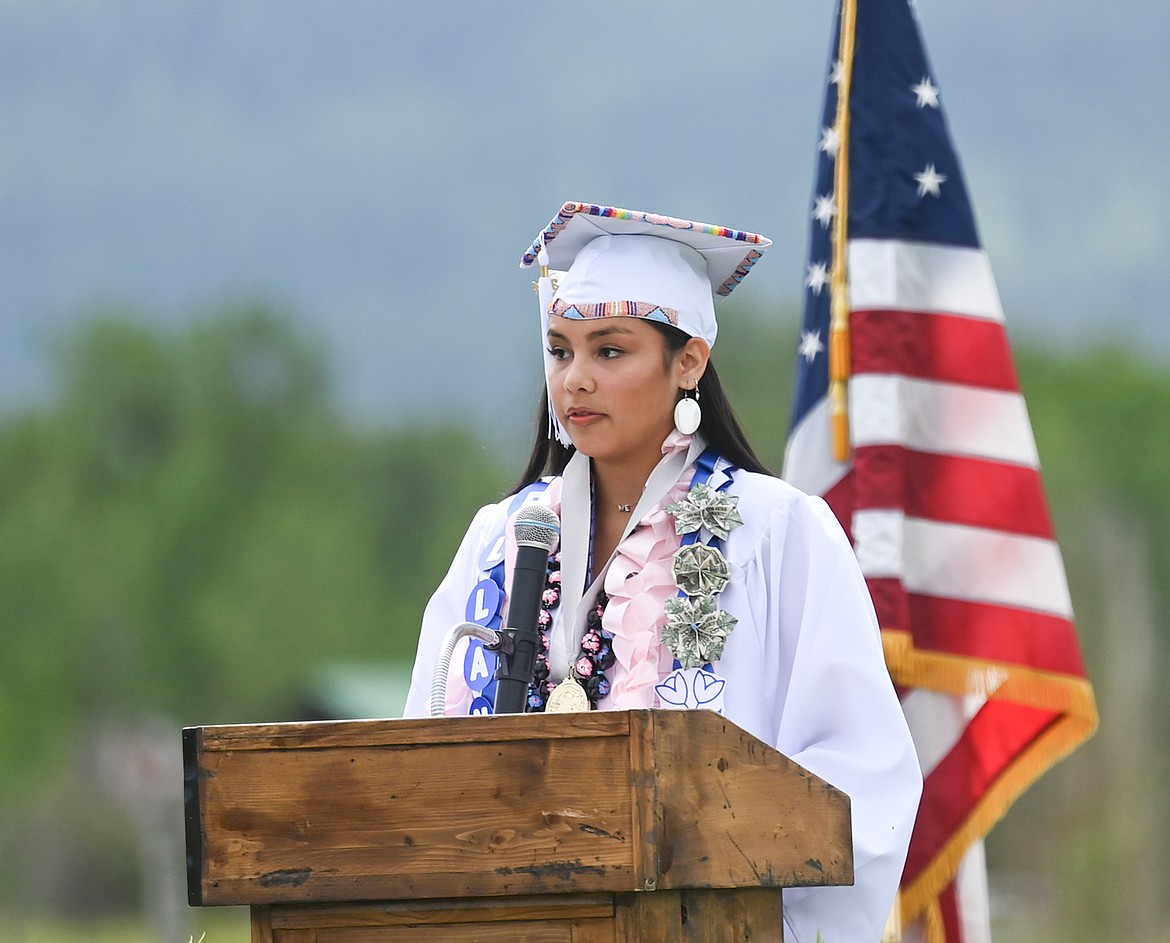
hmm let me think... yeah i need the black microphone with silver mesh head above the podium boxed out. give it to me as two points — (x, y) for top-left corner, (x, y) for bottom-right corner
(494, 504), (560, 714)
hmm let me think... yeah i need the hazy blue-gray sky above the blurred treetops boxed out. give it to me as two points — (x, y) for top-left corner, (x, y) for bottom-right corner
(0, 0), (1170, 428)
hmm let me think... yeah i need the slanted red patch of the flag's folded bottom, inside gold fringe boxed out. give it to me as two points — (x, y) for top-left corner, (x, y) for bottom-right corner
(902, 701), (1060, 886)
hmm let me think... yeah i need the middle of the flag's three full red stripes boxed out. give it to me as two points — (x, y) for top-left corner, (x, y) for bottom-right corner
(853, 445), (1053, 541)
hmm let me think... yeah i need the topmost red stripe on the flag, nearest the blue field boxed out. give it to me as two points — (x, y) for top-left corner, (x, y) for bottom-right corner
(849, 311), (1019, 392)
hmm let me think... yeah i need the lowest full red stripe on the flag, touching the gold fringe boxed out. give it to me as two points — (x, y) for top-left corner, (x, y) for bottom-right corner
(866, 579), (1085, 677)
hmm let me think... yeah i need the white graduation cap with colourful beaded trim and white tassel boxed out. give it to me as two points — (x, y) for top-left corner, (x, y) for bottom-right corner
(519, 202), (772, 446)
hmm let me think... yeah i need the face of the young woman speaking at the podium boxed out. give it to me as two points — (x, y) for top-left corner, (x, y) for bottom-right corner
(549, 315), (707, 470)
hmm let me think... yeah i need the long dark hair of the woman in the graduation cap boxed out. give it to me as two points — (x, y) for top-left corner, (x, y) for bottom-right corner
(512, 321), (772, 494)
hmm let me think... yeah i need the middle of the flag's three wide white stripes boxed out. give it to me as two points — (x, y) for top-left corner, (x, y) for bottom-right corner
(849, 373), (1039, 468)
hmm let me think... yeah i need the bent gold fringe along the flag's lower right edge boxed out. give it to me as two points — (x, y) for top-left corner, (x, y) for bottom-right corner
(882, 628), (1097, 943)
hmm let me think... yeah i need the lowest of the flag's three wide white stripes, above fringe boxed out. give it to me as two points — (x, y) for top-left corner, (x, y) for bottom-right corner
(853, 510), (1073, 619)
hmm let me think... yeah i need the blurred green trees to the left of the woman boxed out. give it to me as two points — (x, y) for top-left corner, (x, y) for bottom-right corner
(0, 304), (503, 789)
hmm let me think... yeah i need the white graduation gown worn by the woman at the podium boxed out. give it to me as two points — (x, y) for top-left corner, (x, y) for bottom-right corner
(406, 436), (922, 943)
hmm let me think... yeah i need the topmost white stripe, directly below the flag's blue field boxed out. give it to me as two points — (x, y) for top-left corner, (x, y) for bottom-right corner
(849, 239), (1004, 322)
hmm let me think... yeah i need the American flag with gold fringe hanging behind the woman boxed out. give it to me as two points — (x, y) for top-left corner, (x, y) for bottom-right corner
(784, 0), (1096, 943)
